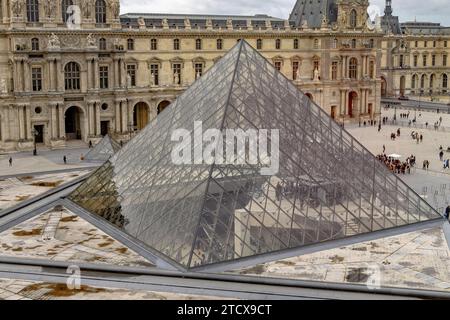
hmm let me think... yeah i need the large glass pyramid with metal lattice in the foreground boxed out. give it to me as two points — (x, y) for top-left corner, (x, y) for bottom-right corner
(70, 41), (442, 269)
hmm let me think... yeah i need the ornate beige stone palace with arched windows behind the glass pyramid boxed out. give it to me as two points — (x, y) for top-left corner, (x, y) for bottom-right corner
(0, 0), (450, 152)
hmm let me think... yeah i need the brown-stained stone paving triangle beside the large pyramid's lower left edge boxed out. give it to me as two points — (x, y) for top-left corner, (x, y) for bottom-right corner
(0, 210), (152, 267)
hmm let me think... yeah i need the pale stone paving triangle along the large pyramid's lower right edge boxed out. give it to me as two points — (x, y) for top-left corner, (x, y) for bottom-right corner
(232, 228), (450, 291)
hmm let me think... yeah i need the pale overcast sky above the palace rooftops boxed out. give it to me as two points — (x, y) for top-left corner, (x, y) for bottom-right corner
(120, 0), (450, 25)
